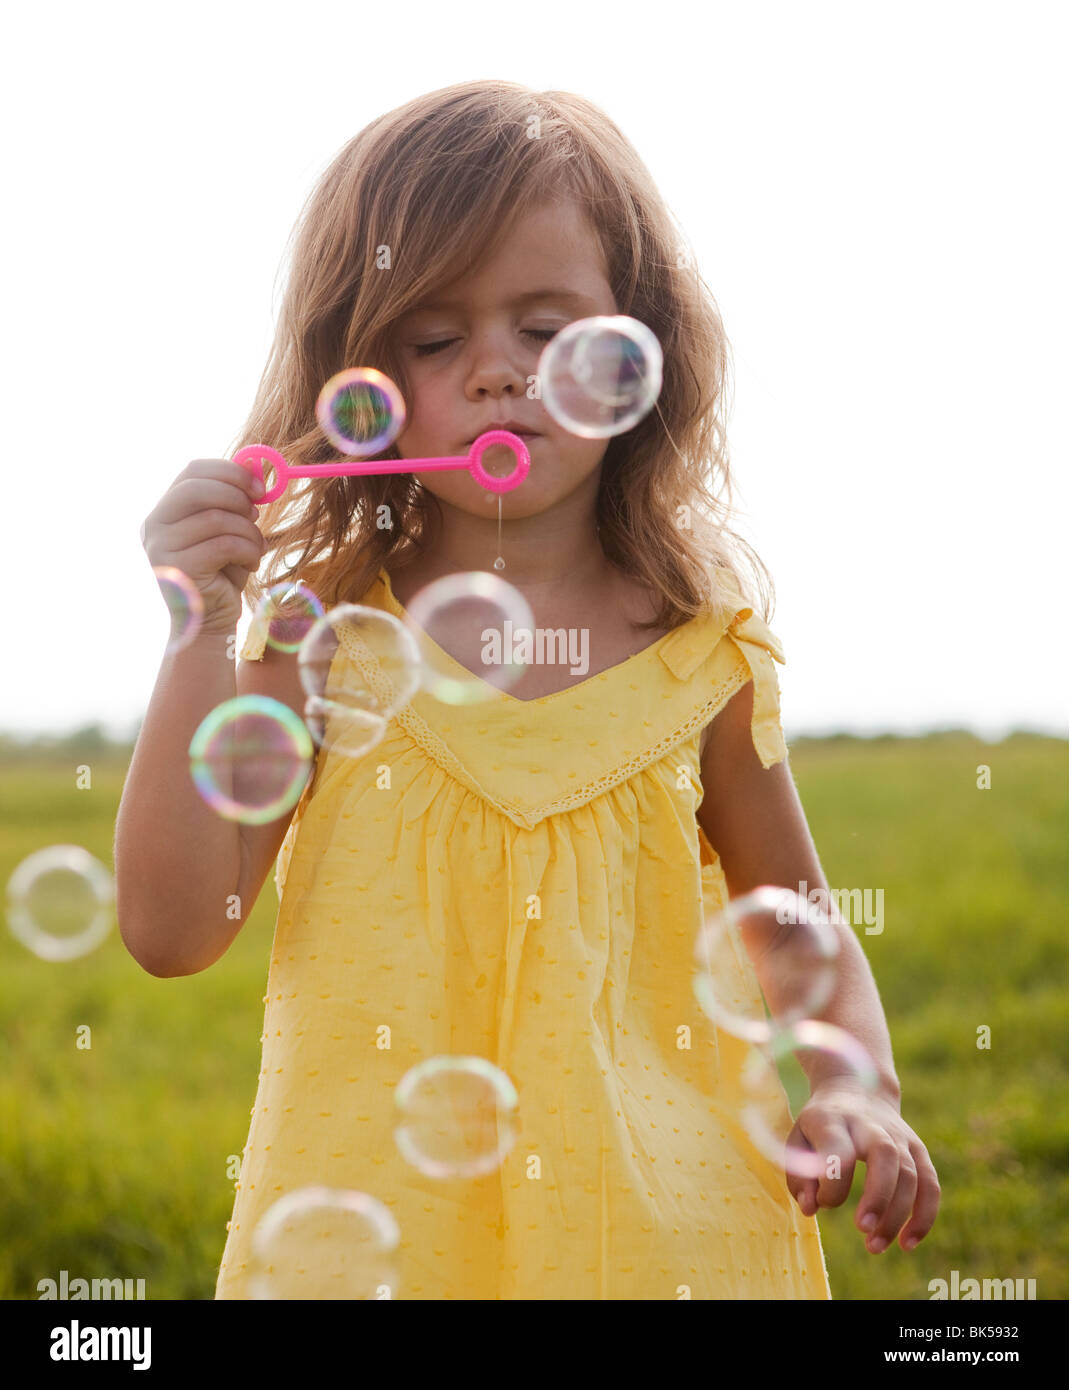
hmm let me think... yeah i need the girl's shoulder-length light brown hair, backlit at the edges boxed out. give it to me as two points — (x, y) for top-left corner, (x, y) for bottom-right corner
(228, 81), (773, 628)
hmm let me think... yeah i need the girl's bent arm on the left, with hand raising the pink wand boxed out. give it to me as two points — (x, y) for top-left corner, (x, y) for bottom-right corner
(115, 459), (303, 976)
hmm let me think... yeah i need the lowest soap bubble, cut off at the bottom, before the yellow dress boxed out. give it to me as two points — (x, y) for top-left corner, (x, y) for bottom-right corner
(249, 1187), (400, 1301)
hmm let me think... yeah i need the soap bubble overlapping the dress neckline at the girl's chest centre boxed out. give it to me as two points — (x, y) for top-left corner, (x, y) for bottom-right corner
(407, 570), (533, 705)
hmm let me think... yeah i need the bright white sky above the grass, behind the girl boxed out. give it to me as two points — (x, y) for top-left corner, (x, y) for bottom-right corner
(0, 0), (1069, 738)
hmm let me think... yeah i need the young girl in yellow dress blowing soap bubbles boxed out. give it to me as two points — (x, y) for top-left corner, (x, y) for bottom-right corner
(115, 82), (938, 1300)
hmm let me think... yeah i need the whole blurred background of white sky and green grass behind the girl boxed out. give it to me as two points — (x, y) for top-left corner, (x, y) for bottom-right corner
(0, 0), (1069, 1298)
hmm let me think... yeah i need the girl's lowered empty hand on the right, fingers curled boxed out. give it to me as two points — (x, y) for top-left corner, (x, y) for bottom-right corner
(787, 1079), (940, 1255)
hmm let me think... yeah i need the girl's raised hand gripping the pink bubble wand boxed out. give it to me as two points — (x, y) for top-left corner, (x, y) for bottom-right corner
(140, 459), (264, 632)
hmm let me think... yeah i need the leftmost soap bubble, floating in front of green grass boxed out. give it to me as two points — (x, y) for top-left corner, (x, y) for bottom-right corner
(7, 845), (115, 960)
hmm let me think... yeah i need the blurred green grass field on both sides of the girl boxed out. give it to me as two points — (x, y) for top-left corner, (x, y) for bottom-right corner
(0, 734), (1069, 1300)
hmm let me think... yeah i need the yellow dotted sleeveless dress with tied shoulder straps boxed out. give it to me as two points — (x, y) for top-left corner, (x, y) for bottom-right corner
(215, 571), (830, 1300)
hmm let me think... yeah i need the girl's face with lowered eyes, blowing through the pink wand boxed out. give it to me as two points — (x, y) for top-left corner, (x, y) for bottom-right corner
(396, 195), (619, 520)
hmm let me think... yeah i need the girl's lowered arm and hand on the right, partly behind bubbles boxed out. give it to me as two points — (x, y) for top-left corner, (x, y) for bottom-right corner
(698, 681), (940, 1254)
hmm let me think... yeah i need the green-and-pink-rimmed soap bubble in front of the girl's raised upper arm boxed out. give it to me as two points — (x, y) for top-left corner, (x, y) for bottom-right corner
(189, 695), (316, 826)
